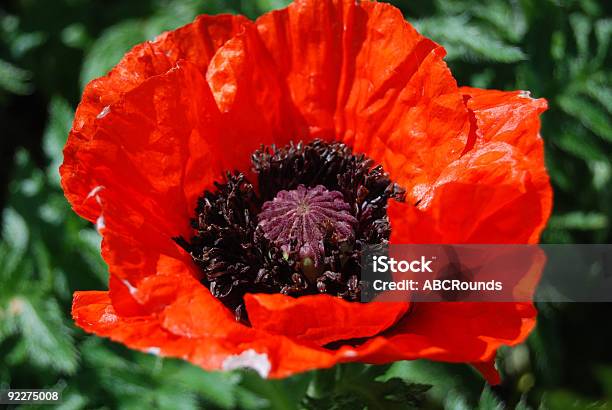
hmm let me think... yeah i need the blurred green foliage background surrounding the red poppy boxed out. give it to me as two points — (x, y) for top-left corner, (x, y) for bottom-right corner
(0, 0), (612, 409)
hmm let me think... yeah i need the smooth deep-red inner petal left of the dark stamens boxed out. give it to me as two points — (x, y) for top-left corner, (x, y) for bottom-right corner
(69, 62), (223, 286)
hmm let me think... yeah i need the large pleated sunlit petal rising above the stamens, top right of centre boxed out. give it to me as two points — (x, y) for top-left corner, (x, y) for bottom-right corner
(257, 0), (470, 199)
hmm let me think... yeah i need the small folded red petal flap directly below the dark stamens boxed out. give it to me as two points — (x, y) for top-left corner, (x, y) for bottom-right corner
(245, 294), (409, 346)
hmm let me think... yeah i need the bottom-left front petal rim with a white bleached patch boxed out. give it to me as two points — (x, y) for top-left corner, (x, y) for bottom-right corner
(72, 291), (344, 378)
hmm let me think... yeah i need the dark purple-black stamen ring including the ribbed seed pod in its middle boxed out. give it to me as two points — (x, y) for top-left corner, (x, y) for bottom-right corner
(175, 140), (404, 323)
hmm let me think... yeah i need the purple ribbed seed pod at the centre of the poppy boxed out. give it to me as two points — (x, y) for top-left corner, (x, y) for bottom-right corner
(257, 185), (357, 267)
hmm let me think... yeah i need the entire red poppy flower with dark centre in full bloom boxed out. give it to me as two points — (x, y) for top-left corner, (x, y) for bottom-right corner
(61, 0), (551, 382)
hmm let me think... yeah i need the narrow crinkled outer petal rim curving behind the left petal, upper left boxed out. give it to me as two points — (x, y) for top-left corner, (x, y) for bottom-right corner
(60, 15), (249, 222)
